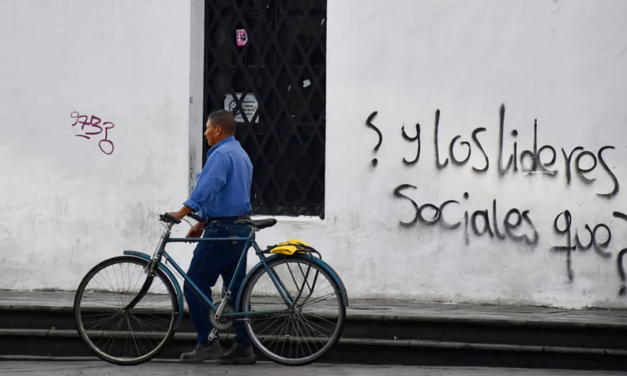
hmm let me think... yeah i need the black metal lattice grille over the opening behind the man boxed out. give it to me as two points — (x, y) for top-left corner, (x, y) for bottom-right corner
(203, 0), (326, 218)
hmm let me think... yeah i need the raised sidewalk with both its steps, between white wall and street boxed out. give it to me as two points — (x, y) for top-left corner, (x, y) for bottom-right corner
(0, 291), (627, 370)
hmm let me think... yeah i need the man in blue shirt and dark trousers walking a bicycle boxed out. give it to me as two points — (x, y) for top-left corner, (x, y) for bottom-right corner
(169, 110), (256, 364)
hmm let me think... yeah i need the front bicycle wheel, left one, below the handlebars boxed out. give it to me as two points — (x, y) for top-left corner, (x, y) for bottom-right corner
(74, 256), (180, 365)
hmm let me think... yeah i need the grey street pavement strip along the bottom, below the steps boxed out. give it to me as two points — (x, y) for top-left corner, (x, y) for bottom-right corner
(0, 361), (625, 376)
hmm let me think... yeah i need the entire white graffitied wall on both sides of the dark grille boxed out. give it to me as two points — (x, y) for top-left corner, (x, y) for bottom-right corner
(0, 0), (627, 307)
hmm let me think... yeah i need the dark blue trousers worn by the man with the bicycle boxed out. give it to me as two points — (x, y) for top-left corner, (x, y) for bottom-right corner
(184, 220), (251, 346)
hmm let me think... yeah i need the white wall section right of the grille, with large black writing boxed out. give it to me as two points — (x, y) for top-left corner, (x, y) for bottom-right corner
(264, 0), (627, 307)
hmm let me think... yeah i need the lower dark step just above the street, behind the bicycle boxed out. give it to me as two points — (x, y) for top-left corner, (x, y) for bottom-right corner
(0, 329), (627, 371)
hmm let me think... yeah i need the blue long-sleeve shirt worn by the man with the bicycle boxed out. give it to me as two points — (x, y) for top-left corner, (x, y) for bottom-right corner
(184, 136), (253, 220)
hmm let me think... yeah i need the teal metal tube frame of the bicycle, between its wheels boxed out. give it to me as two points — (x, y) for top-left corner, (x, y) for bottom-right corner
(147, 223), (293, 319)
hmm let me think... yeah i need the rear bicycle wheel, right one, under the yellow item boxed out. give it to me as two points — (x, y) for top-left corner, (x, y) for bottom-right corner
(241, 256), (346, 366)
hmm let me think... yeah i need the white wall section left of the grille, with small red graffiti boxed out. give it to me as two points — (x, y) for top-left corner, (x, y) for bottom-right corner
(0, 0), (194, 289)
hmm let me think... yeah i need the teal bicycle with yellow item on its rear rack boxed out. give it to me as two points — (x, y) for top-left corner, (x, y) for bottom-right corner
(74, 214), (348, 365)
